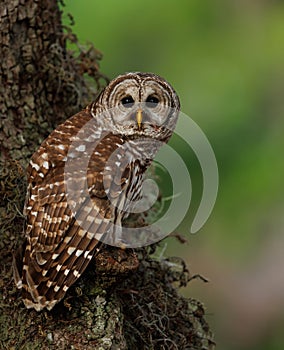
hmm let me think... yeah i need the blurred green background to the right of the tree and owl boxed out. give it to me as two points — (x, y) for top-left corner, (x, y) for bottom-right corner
(63, 0), (284, 350)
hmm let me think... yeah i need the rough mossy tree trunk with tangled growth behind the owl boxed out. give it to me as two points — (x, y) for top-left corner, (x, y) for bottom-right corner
(0, 0), (214, 349)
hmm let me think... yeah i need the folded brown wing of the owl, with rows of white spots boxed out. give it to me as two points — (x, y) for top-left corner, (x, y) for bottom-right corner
(18, 111), (120, 311)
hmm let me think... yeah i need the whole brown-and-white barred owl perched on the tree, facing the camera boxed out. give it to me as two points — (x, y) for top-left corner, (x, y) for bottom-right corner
(14, 73), (180, 311)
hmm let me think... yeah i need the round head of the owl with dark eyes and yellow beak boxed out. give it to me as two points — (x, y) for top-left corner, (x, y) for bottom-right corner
(91, 72), (180, 141)
